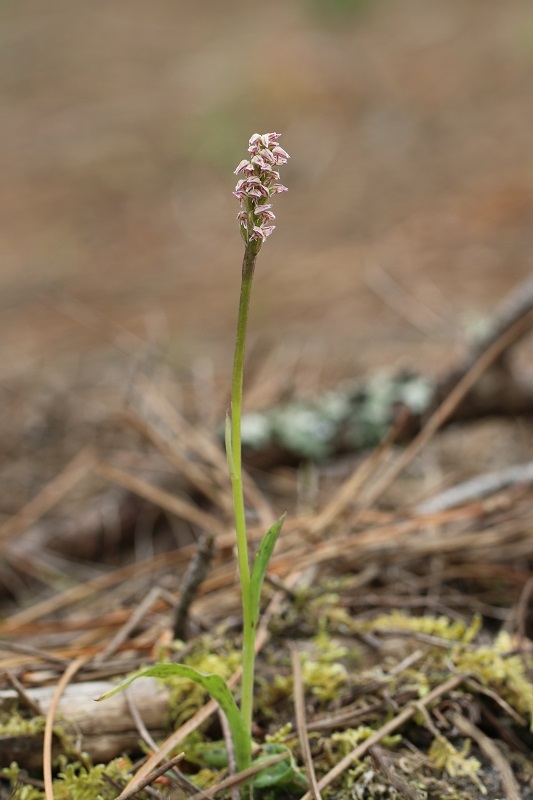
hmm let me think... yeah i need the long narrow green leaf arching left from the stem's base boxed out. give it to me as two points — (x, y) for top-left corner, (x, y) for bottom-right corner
(97, 664), (252, 772)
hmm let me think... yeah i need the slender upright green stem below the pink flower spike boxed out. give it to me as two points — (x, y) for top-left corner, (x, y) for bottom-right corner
(228, 242), (258, 736)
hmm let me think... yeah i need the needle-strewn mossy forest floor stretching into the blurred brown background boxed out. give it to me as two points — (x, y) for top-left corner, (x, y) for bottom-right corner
(0, 0), (533, 800)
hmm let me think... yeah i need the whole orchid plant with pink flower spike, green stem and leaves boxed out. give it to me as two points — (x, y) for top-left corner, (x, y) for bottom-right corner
(99, 133), (301, 796)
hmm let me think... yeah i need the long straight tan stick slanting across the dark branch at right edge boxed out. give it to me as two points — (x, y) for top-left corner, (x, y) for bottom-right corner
(358, 311), (533, 508)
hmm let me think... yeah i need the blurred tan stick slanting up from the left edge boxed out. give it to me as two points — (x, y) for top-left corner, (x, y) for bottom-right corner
(0, 445), (96, 552)
